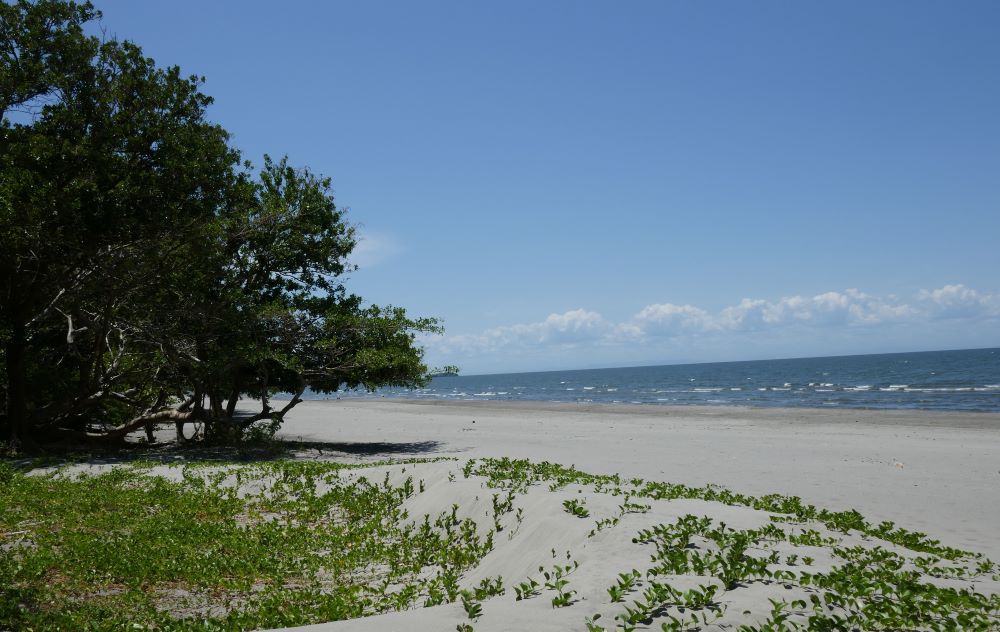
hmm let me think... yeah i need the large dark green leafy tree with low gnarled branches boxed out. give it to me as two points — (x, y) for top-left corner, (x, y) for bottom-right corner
(0, 0), (439, 441)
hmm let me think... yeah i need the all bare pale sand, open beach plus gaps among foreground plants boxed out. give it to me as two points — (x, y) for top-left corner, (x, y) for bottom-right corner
(266, 399), (1000, 631)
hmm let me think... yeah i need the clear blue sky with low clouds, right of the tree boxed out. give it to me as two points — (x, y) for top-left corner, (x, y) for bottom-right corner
(90, 0), (1000, 373)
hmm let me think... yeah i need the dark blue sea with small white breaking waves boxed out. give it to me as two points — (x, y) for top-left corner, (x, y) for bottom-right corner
(313, 349), (1000, 412)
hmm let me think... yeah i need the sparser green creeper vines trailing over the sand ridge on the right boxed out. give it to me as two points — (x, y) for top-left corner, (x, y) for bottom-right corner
(471, 459), (1000, 632)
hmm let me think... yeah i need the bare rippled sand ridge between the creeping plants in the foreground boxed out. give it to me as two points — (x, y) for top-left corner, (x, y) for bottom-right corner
(266, 457), (1000, 632)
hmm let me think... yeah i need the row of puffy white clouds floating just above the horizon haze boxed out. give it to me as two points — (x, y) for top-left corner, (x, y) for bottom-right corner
(425, 285), (1000, 366)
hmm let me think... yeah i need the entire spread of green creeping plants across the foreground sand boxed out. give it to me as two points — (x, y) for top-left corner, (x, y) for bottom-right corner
(0, 459), (1000, 632)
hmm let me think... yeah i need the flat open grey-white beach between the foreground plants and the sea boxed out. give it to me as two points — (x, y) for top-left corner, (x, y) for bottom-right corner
(279, 398), (1000, 559)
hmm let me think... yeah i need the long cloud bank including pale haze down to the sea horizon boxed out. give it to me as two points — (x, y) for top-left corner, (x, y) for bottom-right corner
(422, 284), (1000, 373)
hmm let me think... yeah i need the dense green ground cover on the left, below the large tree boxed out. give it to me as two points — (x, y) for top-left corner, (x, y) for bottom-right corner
(0, 461), (493, 630)
